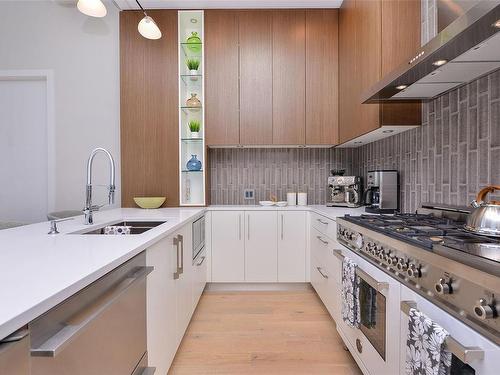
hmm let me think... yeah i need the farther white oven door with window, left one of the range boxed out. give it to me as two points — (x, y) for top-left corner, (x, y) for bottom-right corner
(336, 249), (400, 375)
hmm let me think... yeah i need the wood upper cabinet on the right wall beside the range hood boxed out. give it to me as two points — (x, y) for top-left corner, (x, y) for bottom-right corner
(339, 0), (421, 143)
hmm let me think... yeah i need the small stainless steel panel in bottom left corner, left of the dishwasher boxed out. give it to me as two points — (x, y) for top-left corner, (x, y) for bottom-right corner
(0, 329), (31, 375)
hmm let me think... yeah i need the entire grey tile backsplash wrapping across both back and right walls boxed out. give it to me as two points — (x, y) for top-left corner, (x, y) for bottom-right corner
(209, 70), (500, 212)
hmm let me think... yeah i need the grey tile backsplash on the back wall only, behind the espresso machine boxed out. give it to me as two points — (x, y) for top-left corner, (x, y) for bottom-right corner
(209, 148), (356, 204)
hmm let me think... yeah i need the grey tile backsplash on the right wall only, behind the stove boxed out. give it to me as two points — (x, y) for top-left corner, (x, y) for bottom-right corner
(354, 70), (500, 212)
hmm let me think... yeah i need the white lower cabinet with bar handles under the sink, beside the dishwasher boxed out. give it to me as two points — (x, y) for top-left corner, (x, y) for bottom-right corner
(146, 220), (207, 374)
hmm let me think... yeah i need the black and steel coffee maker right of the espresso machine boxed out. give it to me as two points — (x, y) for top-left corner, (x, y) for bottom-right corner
(363, 170), (399, 214)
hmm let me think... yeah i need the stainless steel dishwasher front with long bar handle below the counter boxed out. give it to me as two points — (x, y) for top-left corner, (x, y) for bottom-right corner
(29, 252), (154, 375)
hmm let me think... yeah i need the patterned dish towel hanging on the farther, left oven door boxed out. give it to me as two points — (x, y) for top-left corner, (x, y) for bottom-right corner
(342, 257), (360, 328)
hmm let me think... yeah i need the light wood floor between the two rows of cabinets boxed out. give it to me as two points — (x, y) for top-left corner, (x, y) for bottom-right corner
(169, 290), (361, 375)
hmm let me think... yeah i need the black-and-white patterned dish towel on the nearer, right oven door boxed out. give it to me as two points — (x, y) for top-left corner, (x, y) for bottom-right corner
(406, 308), (451, 375)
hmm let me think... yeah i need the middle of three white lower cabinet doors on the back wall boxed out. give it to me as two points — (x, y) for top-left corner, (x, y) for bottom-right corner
(245, 211), (278, 282)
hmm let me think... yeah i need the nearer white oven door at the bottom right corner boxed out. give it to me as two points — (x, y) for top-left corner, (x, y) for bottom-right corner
(400, 285), (500, 375)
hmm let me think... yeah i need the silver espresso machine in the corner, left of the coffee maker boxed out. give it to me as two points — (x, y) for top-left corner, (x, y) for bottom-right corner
(326, 170), (362, 207)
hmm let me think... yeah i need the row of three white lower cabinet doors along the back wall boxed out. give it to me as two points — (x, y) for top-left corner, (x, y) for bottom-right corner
(210, 210), (308, 282)
